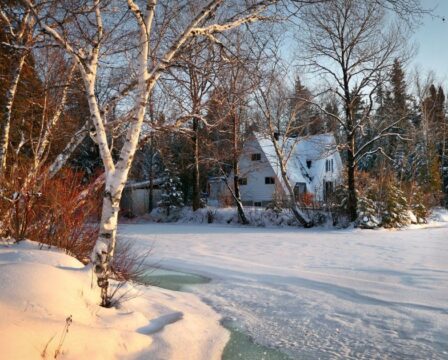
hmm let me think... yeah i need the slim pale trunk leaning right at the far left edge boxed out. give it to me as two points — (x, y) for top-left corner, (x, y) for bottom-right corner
(0, 52), (27, 177)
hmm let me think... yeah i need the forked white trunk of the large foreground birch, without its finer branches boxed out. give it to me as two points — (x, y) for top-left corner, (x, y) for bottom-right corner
(89, 0), (151, 306)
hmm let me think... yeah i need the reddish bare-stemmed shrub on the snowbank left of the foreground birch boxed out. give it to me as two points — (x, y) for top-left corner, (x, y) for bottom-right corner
(0, 168), (101, 262)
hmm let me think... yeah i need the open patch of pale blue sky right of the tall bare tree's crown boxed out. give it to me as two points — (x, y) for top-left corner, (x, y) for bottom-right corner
(410, 0), (448, 84)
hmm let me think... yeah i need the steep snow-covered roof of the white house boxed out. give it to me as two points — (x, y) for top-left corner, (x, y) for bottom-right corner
(254, 133), (342, 190)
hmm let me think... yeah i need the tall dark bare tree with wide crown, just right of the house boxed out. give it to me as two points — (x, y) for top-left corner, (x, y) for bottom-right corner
(299, 0), (411, 221)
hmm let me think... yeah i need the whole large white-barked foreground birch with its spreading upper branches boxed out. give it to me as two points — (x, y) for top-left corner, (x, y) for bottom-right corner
(25, 0), (275, 306)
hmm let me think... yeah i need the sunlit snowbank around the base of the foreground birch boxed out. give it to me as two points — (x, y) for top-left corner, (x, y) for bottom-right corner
(0, 241), (228, 360)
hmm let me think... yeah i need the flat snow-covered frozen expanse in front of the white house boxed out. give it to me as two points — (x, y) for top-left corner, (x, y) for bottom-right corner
(120, 224), (448, 359)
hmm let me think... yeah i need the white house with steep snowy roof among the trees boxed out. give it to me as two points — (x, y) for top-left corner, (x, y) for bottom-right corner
(209, 133), (342, 206)
